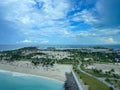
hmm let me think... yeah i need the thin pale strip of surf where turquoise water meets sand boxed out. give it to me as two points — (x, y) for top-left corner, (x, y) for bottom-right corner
(0, 69), (65, 84)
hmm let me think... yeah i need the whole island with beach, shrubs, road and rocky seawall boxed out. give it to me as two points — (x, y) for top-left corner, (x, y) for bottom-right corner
(0, 47), (120, 90)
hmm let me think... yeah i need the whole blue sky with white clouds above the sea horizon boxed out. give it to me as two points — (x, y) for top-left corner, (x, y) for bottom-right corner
(0, 0), (120, 45)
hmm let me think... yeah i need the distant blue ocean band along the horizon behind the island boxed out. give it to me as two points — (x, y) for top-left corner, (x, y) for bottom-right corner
(0, 44), (120, 51)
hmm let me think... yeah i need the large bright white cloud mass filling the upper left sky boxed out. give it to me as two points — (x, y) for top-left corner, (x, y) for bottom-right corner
(0, 0), (70, 42)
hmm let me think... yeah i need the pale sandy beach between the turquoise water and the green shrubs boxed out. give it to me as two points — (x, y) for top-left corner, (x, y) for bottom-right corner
(0, 61), (72, 82)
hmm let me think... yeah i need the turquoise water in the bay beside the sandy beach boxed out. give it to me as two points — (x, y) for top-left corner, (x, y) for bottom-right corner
(0, 72), (64, 90)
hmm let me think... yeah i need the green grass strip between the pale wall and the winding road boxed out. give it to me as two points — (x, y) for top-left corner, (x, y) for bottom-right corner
(75, 70), (111, 90)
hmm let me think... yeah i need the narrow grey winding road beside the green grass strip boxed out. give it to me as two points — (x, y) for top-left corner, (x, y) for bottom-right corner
(77, 61), (118, 90)
